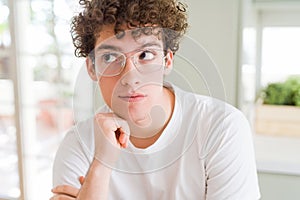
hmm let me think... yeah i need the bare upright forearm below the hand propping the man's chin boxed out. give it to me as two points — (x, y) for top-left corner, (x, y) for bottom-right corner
(77, 159), (112, 200)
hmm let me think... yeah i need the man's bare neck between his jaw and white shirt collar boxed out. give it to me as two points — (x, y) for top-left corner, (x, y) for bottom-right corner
(129, 88), (175, 148)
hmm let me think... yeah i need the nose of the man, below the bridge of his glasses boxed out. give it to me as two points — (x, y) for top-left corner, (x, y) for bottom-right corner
(121, 57), (141, 88)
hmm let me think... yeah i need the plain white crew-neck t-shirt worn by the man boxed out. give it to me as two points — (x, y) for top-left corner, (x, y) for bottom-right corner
(53, 86), (260, 200)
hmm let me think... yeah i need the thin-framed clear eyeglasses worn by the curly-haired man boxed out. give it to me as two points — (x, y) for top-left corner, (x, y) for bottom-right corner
(93, 49), (165, 77)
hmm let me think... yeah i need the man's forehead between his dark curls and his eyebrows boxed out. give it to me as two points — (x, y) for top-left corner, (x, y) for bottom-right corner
(95, 27), (163, 52)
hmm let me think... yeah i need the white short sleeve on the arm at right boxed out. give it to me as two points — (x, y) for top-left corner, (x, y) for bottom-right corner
(205, 110), (260, 200)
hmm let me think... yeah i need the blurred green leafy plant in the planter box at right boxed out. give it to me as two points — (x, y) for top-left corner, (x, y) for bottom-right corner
(261, 76), (300, 106)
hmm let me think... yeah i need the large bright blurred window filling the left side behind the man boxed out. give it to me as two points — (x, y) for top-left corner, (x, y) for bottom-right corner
(0, 0), (86, 200)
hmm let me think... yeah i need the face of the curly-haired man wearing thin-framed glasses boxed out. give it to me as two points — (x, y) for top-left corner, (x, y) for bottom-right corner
(89, 27), (173, 126)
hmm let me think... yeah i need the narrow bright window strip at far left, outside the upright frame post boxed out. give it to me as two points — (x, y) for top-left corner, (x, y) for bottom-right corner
(0, 0), (20, 199)
